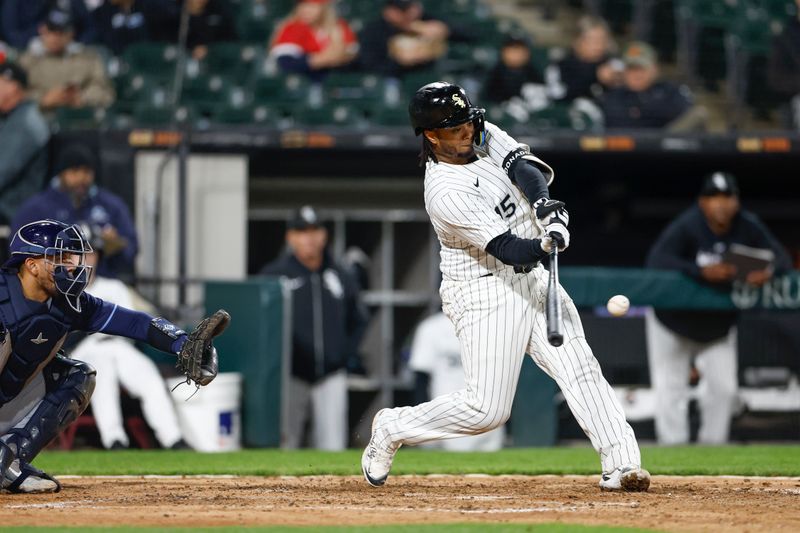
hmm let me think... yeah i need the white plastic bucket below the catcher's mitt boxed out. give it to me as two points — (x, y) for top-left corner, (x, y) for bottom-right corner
(167, 372), (242, 452)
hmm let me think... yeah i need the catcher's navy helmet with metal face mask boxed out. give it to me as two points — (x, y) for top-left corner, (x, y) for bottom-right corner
(3, 219), (92, 311)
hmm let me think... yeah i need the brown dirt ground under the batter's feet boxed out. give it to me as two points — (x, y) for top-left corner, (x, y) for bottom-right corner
(0, 476), (800, 532)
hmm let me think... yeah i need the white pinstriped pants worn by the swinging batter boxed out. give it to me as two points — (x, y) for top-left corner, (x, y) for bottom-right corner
(385, 266), (641, 472)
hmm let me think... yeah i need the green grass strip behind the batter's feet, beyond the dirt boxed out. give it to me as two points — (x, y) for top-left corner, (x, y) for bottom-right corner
(35, 445), (800, 476)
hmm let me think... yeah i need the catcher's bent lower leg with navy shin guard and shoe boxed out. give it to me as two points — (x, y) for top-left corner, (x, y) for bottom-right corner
(0, 355), (96, 492)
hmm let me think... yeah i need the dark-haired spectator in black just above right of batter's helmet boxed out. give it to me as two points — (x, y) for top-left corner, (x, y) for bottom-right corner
(483, 36), (544, 102)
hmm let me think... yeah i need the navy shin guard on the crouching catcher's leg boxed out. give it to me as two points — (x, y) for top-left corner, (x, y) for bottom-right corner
(0, 355), (97, 462)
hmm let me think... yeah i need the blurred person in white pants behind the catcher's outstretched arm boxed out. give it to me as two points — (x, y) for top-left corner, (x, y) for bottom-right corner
(70, 236), (189, 450)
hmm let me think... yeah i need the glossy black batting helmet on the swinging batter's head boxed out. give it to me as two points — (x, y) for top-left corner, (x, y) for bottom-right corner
(408, 81), (485, 135)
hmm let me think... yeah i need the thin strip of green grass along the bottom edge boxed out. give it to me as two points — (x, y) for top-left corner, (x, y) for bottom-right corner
(3, 523), (655, 533)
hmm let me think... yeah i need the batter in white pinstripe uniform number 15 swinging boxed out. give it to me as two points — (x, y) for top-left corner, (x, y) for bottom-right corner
(361, 82), (650, 491)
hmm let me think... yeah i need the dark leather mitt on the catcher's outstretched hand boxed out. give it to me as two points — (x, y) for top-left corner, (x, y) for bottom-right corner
(175, 309), (231, 387)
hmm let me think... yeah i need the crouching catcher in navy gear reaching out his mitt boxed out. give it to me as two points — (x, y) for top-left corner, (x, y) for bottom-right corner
(0, 220), (230, 493)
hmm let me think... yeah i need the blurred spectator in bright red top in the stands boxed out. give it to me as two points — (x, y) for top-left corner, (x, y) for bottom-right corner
(270, 0), (358, 79)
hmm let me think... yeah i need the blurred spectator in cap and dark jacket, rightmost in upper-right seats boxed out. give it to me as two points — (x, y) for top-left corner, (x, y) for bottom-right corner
(602, 42), (707, 132)
